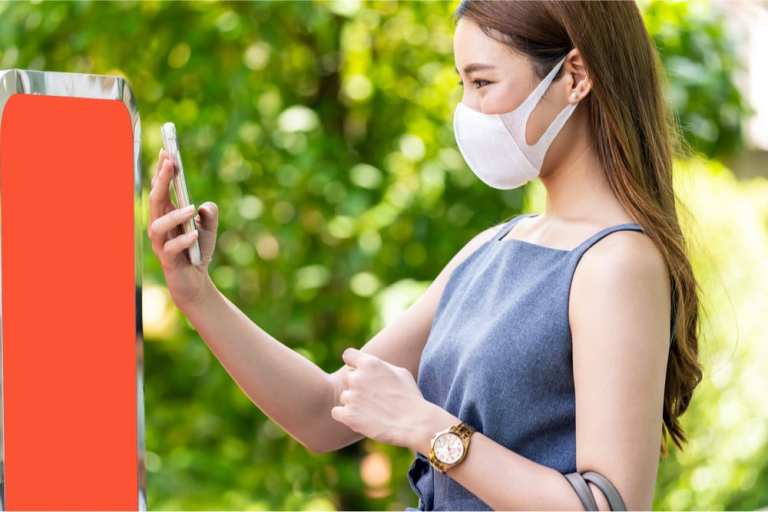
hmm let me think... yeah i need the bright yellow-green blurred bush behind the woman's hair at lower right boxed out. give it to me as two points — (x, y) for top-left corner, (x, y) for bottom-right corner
(655, 160), (768, 510)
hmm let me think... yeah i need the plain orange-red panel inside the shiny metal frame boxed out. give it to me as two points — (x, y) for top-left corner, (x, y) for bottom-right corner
(0, 94), (138, 510)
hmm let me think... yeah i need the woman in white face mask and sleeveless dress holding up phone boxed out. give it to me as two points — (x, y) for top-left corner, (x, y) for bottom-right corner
(148, 1), (701, 510)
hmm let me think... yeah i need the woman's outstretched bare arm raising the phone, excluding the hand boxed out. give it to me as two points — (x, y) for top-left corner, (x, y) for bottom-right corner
(179, 222), (498, 452)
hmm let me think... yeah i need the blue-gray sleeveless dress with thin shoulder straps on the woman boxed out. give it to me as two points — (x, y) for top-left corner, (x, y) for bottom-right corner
(406, 211), (642, 510)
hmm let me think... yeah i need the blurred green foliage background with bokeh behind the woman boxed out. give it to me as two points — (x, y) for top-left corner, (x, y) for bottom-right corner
(0, 0), (768, 510)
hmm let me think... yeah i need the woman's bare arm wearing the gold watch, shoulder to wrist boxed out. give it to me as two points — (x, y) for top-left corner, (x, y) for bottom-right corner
(414, 233), (670, 510)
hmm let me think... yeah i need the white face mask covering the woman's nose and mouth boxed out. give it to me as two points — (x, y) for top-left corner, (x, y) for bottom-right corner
(453, 57), (577, 189)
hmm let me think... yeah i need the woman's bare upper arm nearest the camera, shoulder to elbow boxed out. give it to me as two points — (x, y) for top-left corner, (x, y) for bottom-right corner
(571, 231), (671, 510)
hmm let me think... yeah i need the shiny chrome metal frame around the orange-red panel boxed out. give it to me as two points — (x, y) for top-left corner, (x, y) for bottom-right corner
(0, 69), (147, 511)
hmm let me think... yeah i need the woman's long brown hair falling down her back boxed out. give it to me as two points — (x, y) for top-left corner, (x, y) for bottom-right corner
(454, 0), (702, 456)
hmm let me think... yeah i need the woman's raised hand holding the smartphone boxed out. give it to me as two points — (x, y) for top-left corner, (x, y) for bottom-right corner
(147, 150), (219, 310)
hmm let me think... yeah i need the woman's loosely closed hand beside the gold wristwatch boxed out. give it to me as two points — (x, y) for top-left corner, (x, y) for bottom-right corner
(331, 348), (455, 453)
